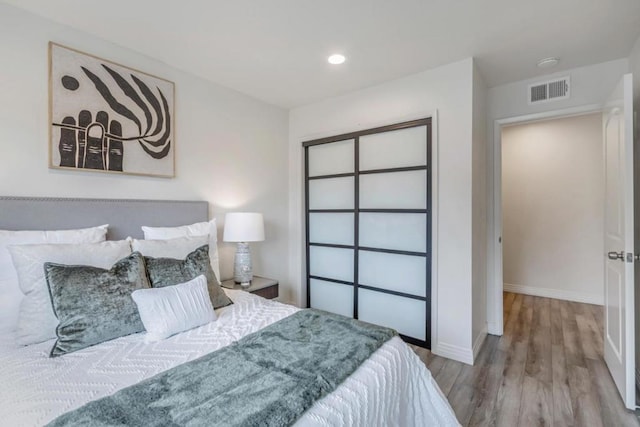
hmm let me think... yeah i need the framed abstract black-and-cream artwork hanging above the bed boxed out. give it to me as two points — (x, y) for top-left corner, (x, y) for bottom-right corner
(49, 42), (175, 177)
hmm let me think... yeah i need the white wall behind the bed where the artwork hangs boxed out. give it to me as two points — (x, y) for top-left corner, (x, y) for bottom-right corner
(0, 4), (289, 300)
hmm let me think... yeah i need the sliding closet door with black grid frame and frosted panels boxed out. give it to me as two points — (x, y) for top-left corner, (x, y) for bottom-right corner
(303, 119), (431, 347)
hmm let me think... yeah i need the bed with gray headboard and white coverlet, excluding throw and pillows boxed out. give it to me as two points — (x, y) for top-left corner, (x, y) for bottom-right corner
(0, 198), (458, 426)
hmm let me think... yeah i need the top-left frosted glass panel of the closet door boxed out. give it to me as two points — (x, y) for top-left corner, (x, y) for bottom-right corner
(308, 139), (354, 176)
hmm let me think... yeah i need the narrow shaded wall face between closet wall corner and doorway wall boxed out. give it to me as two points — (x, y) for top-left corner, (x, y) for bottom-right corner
(472, 67), (488, 356)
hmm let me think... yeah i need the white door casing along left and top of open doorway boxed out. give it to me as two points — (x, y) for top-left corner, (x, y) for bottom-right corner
(487, 104), (602, 335)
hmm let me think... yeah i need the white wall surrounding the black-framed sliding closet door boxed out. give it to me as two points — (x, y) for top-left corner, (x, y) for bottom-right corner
(289, 59), (473, 363)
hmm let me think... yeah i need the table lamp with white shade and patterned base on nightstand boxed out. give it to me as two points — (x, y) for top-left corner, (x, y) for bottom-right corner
(224, 212), (264, 287)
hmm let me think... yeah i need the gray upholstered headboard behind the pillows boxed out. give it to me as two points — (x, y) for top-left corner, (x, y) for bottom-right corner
(0, 197), (209, 240)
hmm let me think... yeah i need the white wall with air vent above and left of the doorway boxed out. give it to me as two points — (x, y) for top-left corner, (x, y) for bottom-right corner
(487, 58), (629, 332)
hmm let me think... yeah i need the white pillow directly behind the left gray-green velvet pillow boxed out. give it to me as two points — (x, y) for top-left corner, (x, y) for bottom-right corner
(9, 240), (131, 345)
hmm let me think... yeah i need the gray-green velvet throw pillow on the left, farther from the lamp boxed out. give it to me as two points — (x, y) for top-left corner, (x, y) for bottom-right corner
(44, 252), (150, 357)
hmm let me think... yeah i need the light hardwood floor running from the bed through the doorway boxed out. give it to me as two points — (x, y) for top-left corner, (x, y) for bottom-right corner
(414, 292), (640, 427)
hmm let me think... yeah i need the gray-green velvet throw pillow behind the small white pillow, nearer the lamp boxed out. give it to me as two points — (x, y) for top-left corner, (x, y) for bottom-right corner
(144, 245), (233, 308)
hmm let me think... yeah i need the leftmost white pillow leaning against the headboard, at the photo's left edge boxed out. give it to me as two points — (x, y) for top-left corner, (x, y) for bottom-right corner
(0, 224), (108, 333)
